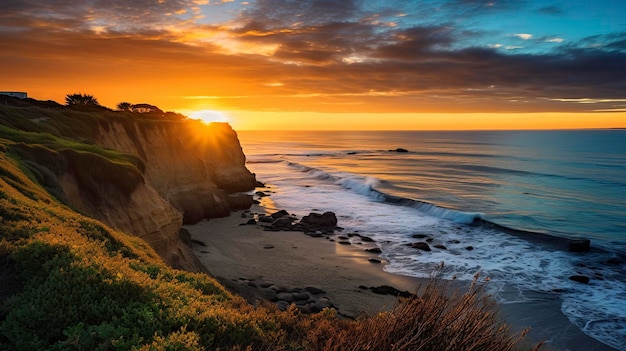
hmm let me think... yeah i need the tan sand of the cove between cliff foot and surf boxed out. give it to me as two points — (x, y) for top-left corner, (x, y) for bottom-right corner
(185, 208), (425, 318)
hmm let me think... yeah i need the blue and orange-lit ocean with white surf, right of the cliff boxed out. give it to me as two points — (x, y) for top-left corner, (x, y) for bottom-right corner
(238, 130), (626, 350)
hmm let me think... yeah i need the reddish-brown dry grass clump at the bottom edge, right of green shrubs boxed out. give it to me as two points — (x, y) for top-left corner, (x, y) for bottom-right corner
(302, 277), (541, 351)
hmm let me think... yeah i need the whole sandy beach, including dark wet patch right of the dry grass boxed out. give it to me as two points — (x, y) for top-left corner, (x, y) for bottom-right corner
(185, 206), (613, 351)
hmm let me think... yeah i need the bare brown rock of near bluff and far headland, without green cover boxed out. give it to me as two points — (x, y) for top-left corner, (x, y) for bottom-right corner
(59, 120), (256, 271)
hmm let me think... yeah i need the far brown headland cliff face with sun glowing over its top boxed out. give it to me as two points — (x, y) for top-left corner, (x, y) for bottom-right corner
(96, 121), (255, 223)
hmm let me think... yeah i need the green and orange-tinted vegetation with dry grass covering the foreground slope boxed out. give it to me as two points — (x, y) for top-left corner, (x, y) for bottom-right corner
(0, 100), (536, 351)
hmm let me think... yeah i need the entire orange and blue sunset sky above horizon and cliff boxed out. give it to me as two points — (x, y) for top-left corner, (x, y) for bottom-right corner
(0, 0), (626, 130)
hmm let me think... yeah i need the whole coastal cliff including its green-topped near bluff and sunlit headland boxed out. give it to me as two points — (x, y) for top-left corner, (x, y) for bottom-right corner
(0, 100), (255, 271)
